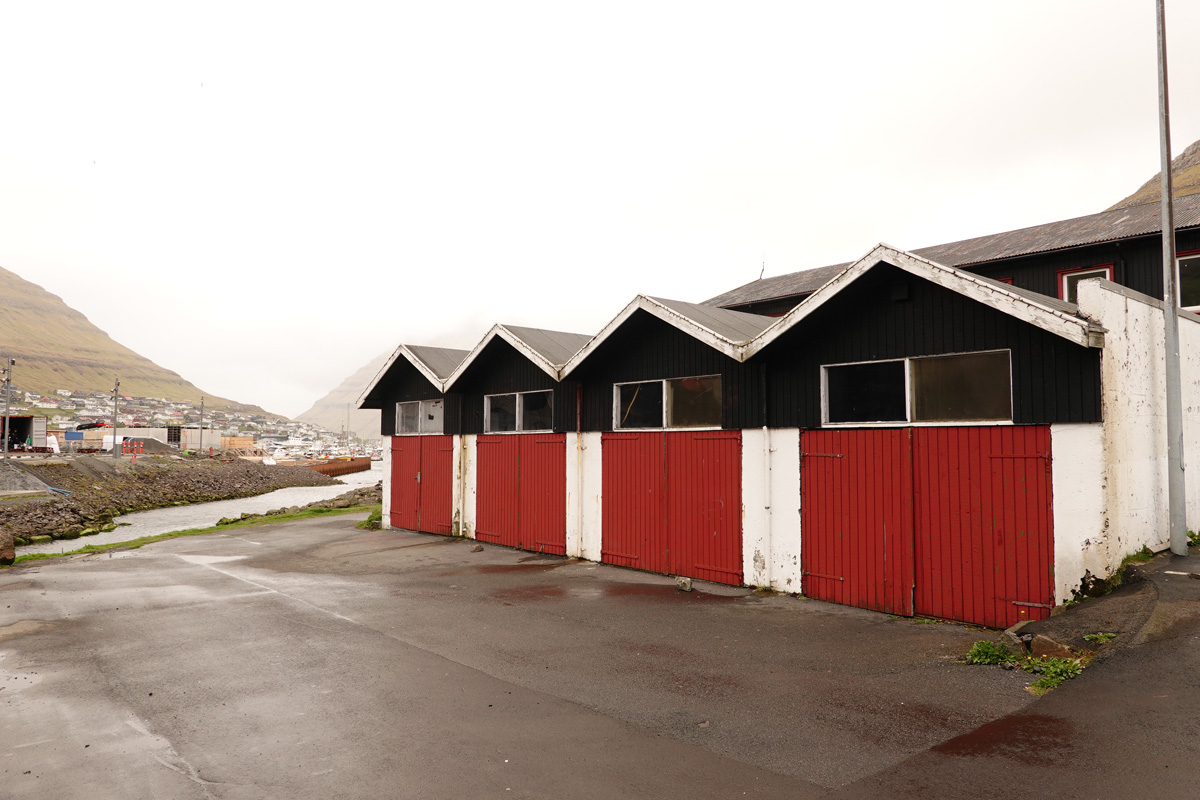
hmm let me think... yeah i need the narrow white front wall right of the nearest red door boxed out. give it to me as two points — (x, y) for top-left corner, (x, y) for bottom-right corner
(1050, 422), (1104, 603)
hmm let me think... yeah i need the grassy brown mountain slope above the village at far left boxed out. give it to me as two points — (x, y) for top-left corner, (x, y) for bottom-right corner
(0, 267), (272, 416)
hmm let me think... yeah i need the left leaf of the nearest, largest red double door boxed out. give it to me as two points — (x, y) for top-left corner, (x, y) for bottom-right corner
(800, 429), (913, 615)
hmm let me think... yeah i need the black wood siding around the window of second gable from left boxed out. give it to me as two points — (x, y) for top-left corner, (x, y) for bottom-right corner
(450, 338), (575, 434)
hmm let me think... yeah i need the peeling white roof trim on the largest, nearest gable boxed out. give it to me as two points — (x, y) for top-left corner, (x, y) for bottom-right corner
(743, 243), (1103, 359)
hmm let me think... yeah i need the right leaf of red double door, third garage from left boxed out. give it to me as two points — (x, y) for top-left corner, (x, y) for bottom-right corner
(666, 431), (742, 585)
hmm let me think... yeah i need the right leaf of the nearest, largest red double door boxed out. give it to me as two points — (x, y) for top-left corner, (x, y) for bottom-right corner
(913, 426), (1054, 627)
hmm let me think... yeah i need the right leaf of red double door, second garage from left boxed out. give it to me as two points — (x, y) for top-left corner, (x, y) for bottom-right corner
(520, 433), (566, 555)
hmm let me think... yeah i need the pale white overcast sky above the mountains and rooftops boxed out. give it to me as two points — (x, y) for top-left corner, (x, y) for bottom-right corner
(0, 0), (1200, 416)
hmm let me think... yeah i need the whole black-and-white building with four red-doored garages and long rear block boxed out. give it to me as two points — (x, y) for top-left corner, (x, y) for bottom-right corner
(360, 194), (1200, 627)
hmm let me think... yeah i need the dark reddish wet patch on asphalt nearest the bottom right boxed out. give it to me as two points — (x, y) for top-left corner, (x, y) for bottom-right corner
(932, 714), (1073, 766)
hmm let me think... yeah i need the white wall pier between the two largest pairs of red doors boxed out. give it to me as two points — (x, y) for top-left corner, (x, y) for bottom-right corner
(742, 428), (800, 593)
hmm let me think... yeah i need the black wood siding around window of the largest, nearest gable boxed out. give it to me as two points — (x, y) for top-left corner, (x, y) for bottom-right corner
(748, 264), (1100, 428)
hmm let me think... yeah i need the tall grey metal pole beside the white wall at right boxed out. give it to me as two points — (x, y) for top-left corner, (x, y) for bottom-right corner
(1157, 0), (1188, 555)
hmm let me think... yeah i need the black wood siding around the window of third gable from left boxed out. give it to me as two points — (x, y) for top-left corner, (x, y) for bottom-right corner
(570, 311), (762, 431)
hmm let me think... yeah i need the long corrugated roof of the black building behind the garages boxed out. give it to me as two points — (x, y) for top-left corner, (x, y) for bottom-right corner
(704, 194), (1200, 306)
